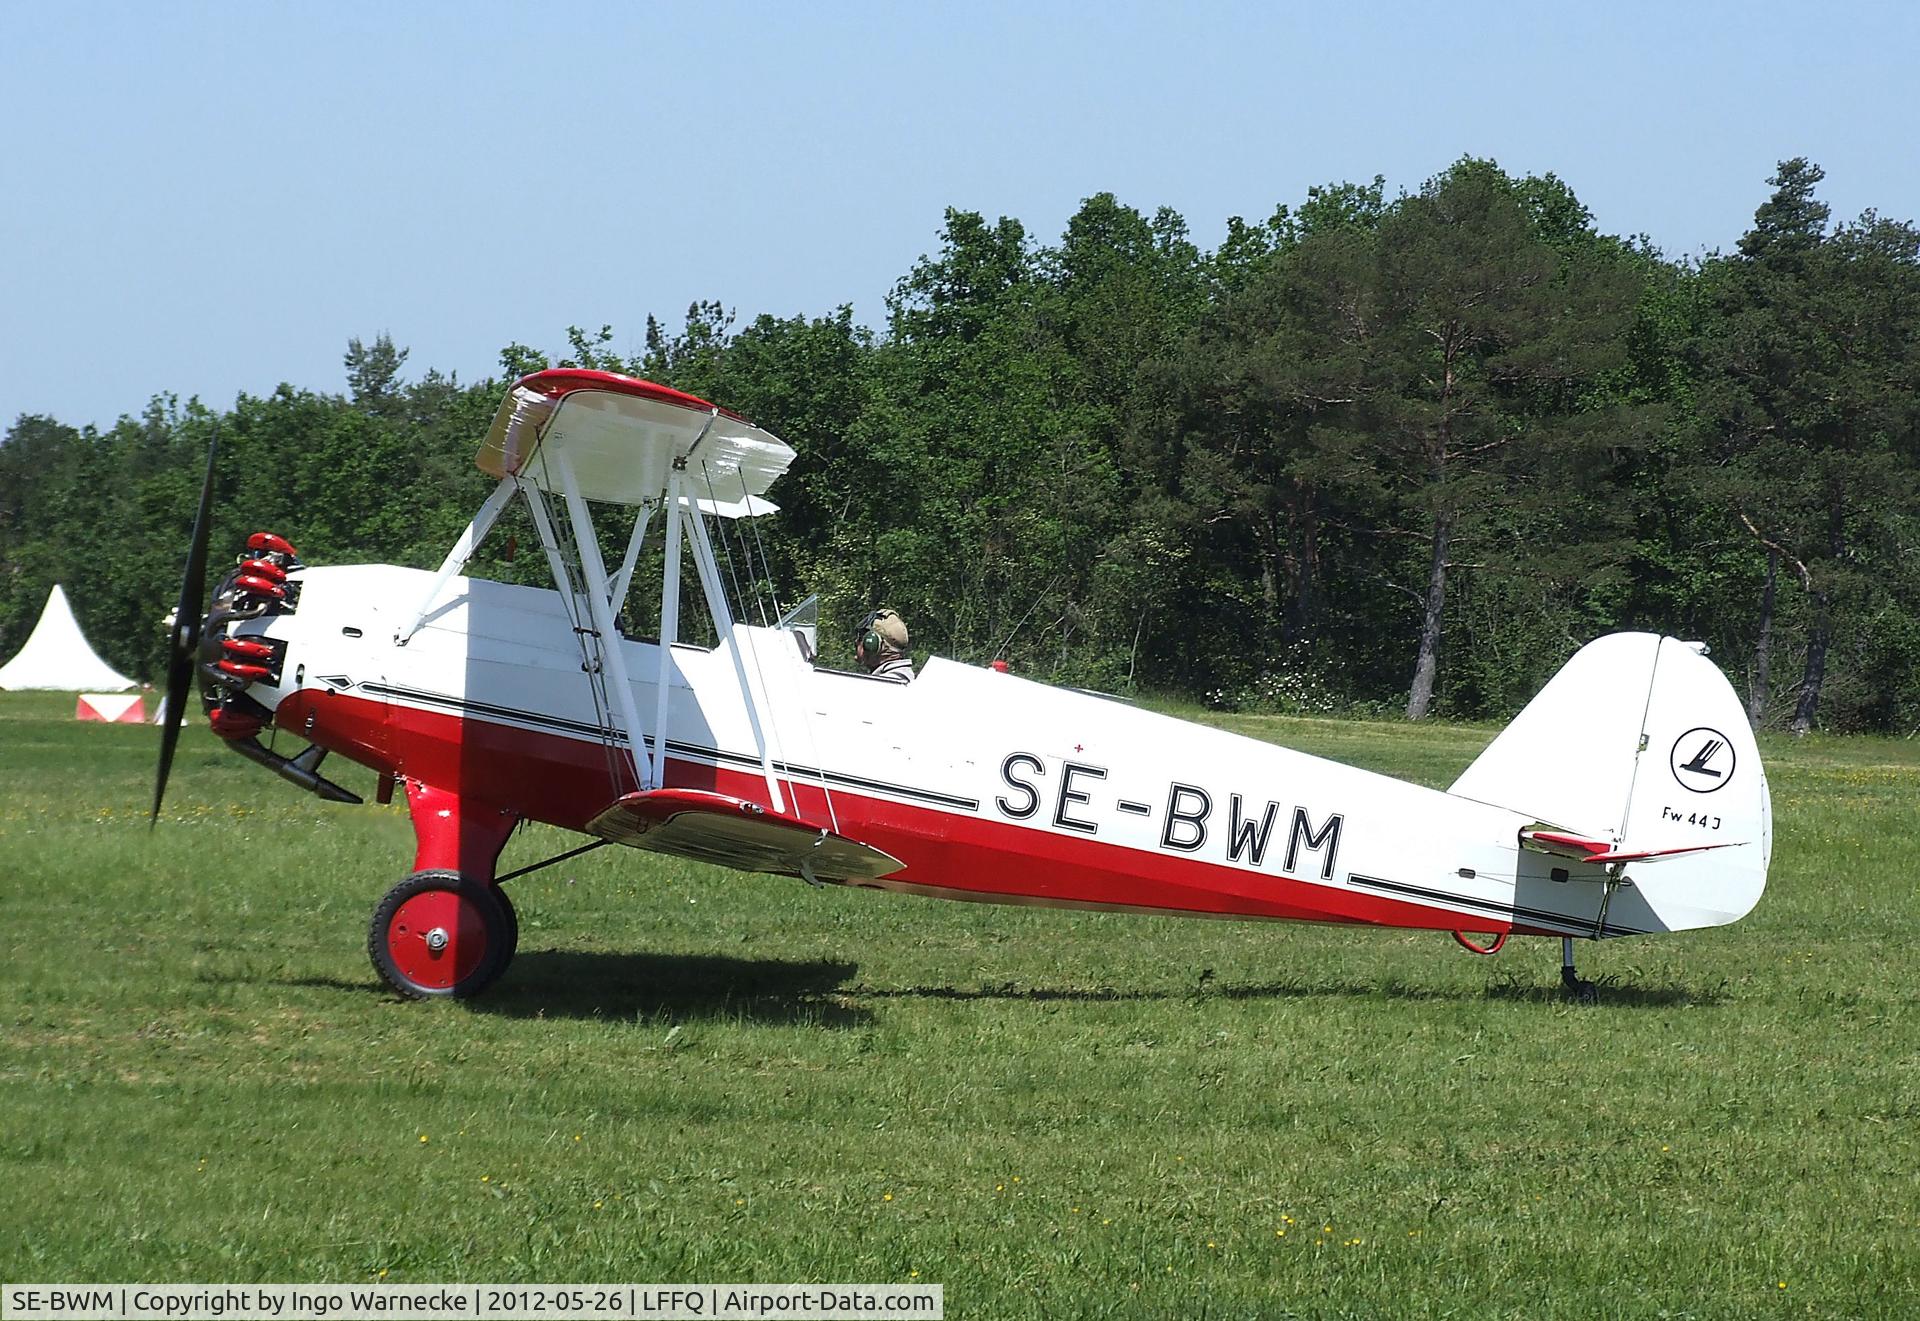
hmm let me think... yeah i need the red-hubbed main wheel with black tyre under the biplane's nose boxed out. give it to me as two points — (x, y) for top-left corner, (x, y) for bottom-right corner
(367, 872), (520, 1000)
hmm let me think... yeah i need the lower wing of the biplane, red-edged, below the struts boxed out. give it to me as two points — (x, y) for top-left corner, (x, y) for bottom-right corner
(588, 789), (904, 881)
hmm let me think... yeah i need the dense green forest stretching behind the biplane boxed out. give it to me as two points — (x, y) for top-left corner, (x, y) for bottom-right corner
(0, 157), (1920, 735)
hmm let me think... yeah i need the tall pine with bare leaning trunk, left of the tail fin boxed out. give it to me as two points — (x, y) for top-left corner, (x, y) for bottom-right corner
(1213, 159), (1644, 718)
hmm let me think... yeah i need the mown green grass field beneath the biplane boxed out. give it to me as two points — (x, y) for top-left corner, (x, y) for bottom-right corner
(0, 695), (1920, 1317)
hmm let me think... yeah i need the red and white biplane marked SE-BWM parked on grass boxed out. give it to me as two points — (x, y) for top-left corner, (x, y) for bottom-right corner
(154, 369), (1772, 997)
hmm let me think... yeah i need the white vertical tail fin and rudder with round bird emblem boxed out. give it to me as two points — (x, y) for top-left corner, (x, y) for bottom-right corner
(1452, 634), (1772, 929)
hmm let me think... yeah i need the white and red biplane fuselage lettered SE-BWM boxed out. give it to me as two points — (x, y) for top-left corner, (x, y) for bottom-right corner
(234, 564), (1668, 937)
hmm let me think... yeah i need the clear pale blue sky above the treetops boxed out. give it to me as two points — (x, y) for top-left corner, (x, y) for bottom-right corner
(0, 0), (1920, 426)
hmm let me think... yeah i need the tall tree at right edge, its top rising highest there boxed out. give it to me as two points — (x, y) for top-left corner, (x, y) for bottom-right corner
(1693, 157), (1920, 733)
